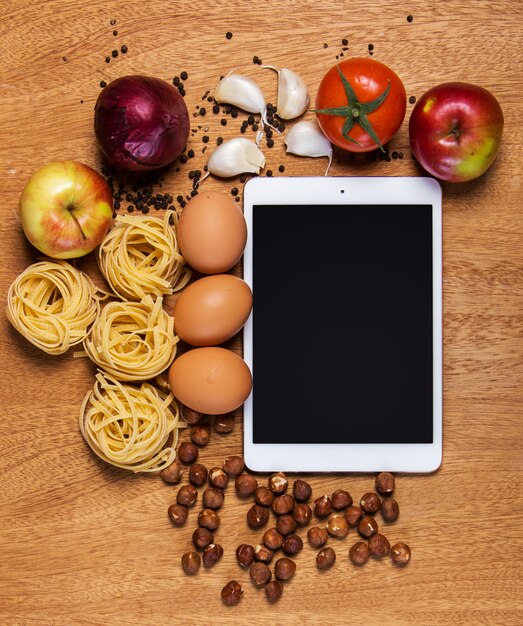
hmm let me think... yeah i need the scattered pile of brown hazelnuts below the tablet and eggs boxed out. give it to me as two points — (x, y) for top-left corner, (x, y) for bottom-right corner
(161, 404), (411, 605)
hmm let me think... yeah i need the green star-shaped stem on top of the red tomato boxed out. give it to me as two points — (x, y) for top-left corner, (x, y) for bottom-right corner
(313, 65), (390, 152)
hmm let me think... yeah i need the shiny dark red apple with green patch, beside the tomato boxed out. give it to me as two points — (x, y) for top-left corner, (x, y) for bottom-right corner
(409, 83), (503, 183)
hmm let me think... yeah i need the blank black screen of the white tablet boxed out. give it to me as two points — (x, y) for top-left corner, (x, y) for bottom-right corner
(252, 205), (433, 444)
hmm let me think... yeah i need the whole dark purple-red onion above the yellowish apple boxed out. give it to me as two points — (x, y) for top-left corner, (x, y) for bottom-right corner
(94, 76), (190, 172)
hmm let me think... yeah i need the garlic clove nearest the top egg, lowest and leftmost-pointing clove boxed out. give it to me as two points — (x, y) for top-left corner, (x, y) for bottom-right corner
(206, 137), (265, 180)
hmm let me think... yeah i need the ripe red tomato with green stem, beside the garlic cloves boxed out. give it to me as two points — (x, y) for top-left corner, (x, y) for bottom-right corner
(315, 58), (407, 152)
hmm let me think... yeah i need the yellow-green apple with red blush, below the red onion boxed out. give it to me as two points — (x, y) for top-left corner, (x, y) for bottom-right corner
(19, 161), (113, 259)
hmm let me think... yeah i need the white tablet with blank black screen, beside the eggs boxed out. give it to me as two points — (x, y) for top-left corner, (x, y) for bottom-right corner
(244, 177), (442, 472)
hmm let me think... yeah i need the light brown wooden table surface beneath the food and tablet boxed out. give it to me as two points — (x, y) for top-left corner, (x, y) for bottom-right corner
(0, 0), (523, 626)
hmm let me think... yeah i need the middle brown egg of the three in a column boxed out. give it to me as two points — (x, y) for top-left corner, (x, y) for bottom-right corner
(173, 274), (252, 346)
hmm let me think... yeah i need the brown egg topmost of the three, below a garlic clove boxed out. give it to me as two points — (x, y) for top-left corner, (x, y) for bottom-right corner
(177, 191), (247, 274)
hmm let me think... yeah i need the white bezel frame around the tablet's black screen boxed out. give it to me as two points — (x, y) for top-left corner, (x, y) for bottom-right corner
(243, 176), (443, 473)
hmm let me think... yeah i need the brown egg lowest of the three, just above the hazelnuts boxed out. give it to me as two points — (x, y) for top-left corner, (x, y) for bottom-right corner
(169, 348), (252, 415)
